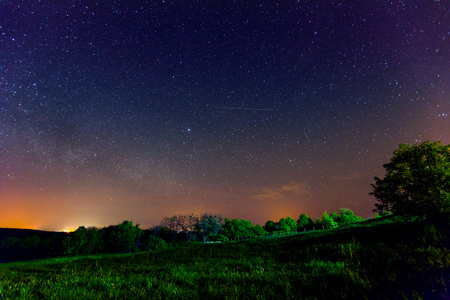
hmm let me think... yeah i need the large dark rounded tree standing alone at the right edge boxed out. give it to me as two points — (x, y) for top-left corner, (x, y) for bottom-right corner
(370, 141), (450, 217)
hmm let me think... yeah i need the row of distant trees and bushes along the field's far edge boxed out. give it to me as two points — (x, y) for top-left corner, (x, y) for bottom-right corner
(57, 208), (364, 255)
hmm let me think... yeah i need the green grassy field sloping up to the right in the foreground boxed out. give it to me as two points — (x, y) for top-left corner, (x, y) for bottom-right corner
(0, 219), (450, 299)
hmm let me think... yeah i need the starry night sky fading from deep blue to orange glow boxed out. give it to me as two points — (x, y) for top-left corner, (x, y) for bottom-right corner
(0, 0), (450, 230)
